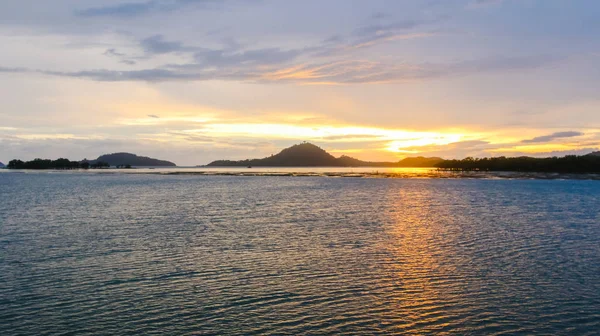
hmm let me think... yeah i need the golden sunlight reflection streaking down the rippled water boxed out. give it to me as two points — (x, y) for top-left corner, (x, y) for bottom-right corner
(384, 186), (454, 333)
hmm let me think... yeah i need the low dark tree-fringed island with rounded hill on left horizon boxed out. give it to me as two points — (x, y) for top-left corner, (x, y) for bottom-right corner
(7, 153), (176, 170)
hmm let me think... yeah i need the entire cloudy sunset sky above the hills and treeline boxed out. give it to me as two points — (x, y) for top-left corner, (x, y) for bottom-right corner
(0, 0), (600, 166)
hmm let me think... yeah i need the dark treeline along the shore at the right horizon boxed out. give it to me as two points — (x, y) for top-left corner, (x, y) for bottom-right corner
(435, 155), (600, 173)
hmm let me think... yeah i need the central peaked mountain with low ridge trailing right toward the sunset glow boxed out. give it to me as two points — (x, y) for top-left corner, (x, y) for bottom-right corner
(207, 142), (443, 167)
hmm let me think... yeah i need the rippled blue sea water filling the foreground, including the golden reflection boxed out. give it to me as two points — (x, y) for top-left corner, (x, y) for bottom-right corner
(0, 173), (600, 335)
